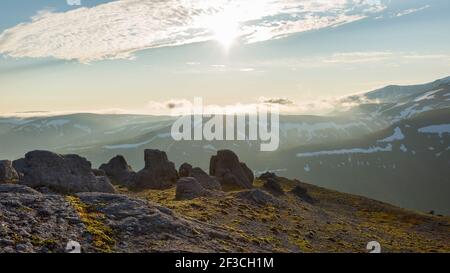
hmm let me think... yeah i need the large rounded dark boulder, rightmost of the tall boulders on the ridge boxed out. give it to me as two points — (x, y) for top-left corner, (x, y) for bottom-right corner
(209, 150), (254, 189)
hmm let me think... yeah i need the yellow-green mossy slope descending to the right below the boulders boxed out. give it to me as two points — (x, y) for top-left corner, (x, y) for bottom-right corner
(123, 176), (450, 252)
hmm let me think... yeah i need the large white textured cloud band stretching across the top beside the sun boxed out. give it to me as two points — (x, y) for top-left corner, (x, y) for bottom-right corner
(0, 0), (385, 63)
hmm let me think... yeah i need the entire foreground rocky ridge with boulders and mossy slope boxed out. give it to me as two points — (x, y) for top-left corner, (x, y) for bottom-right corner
(0, 150), (450, 253)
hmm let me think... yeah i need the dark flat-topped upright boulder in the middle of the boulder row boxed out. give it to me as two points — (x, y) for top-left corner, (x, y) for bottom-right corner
(132, 150), (178, 189)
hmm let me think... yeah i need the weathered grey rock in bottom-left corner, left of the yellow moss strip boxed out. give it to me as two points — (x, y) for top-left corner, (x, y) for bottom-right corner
(0, 188), (85, 253)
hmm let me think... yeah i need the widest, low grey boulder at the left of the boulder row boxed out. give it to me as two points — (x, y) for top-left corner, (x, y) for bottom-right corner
(15, 151), (115, 193)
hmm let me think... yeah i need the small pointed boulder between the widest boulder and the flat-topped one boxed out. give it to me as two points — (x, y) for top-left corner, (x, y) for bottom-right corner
(100, 155), (136, 186)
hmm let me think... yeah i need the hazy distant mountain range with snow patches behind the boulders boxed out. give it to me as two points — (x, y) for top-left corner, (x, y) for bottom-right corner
(0, 77), (450, 214)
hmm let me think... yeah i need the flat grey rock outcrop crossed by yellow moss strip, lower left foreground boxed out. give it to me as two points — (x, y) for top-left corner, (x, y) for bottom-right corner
(0, 188), (236, 253)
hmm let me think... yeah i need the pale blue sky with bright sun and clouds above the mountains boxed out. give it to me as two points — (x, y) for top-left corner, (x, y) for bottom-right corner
(0, 0), (450, 115)
